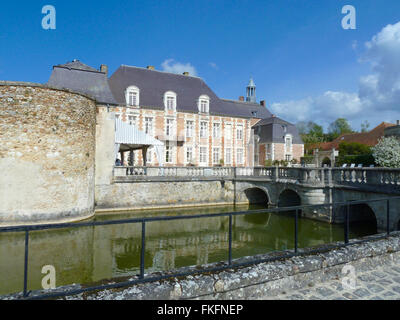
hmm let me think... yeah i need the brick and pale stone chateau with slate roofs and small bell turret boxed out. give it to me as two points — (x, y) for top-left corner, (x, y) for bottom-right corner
(48, 60), (304, 167)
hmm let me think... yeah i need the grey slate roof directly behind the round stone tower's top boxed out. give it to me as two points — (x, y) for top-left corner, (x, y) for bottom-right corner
(47, 60), (117, 105)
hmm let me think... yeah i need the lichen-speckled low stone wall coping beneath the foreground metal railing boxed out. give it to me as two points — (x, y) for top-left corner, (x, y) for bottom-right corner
(0, 232), (400, 300)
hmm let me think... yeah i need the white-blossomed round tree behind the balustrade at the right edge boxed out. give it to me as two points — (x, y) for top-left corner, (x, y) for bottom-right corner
(372, 137), (400, 168)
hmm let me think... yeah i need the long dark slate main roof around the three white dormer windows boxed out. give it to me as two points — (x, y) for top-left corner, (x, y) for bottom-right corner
(109, 65), (271, 119)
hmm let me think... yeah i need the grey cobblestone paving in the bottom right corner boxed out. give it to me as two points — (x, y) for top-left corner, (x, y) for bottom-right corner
(264, 266), (400, 300)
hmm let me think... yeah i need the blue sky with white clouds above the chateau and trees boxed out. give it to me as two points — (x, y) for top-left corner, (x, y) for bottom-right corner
(0, 0), (400, 129)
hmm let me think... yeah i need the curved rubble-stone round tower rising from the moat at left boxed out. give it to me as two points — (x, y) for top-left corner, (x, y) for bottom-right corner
(0, 82), (96, 225)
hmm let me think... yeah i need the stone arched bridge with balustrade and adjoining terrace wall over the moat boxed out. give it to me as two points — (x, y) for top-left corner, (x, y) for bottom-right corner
(96, 167), (400, 230)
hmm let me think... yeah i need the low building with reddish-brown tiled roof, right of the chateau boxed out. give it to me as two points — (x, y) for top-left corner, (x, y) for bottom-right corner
(312, 122), (395, 166)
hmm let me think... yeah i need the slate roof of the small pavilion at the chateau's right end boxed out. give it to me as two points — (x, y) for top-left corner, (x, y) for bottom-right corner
(253, 117), (303, 144)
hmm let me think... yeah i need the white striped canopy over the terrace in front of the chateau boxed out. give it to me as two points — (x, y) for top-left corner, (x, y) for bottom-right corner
(115, 119), (164, 166)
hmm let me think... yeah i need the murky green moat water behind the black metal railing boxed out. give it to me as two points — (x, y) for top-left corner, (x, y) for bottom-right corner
(0, 206), (375, 294)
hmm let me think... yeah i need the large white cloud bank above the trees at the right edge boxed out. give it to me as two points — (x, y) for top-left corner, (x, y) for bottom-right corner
(271, 22), (400, 128)
